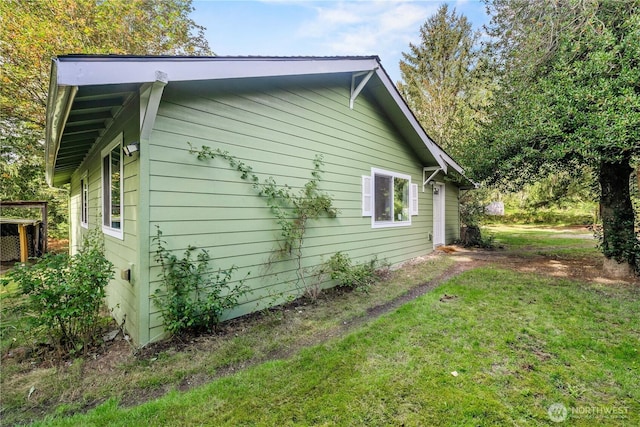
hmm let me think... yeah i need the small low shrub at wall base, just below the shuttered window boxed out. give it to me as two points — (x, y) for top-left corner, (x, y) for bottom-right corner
(325, 252), (389, 292)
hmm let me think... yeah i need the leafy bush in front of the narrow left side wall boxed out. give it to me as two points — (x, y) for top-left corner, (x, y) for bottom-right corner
(2, 230), (113, 356)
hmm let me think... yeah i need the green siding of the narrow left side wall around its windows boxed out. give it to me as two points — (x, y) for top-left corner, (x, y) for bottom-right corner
(69, 98), (143, 342)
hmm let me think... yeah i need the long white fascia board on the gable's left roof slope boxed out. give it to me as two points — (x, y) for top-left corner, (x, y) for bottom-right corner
(55, 57), (378, 86)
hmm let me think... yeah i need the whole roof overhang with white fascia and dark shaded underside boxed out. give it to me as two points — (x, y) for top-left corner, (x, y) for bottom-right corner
(47, 56), (463, 183)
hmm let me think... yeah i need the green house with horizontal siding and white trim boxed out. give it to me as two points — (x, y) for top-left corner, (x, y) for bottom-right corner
(46, 55), (472, 346)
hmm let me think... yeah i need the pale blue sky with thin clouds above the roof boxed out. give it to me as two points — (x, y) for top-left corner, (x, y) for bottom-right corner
(191, 0), (488, 81)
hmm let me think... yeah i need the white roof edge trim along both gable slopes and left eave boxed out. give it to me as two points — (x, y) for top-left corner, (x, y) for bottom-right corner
(45, 56), (464, 185)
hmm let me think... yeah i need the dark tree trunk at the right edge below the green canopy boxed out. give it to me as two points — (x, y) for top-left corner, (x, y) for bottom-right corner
(599, 158), (640, 275)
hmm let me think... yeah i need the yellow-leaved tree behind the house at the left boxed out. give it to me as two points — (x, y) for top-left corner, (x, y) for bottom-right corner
(0, 0), (212, 237)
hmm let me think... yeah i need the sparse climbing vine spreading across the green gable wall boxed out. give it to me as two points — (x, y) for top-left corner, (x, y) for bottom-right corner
(189, 143), (338, 288)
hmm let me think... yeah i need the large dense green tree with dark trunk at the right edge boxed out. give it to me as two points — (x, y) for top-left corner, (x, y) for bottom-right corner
(470, 0), (640, 269)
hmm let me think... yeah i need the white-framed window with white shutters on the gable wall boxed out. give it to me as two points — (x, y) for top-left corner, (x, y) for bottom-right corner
(362, 168), (418, 228)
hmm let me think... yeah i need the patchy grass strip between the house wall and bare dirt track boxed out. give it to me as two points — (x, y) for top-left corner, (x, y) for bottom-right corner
(0, 257), (454, 425)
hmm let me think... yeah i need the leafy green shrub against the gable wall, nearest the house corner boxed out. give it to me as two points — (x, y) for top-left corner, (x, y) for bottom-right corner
(153, 228), (246, 335)
